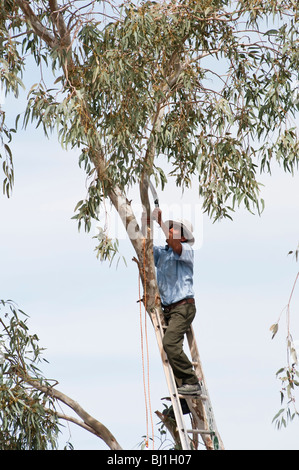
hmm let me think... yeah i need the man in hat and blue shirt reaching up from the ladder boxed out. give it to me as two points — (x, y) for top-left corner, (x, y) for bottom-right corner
(152, 208), (201, 395)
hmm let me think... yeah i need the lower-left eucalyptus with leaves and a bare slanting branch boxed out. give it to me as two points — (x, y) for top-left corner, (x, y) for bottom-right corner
(0, 300), (121, 450)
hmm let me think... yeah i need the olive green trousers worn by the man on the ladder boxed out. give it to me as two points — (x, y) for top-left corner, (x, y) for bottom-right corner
(163, 304), (198, 384)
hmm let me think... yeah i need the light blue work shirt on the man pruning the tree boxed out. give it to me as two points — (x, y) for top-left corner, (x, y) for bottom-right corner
(154, 243), (194, 305)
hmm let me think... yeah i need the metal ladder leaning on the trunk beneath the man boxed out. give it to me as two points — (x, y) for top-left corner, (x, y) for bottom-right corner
(150, 307), (224, 450)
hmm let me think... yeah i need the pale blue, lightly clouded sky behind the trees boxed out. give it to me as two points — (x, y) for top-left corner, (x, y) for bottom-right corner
(0, 8), (299, 450)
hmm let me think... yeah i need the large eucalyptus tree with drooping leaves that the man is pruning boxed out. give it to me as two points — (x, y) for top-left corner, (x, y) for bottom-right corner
(0, 0), (299, 450)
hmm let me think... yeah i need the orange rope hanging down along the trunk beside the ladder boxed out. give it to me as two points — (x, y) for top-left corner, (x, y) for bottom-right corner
(138, 238), (154, 449)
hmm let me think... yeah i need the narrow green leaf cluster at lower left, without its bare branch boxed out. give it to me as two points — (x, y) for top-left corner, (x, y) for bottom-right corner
(0, 300), (59, 450)
